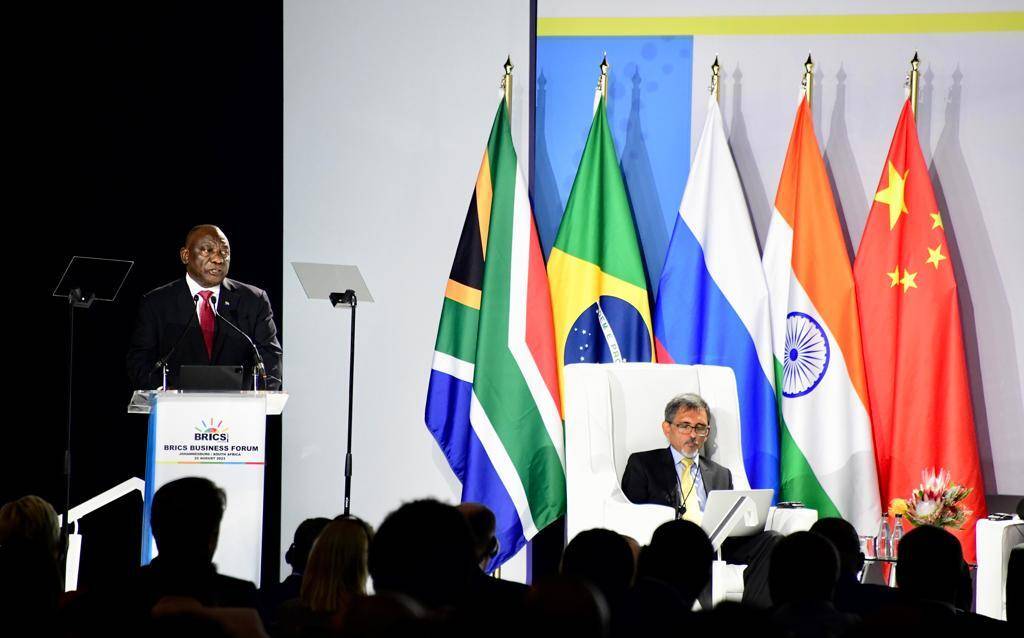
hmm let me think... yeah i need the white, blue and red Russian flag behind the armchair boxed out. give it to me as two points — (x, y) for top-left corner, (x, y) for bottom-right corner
(654, 97), (779, 497)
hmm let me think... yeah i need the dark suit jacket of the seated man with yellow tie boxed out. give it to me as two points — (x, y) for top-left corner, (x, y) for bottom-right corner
(623, 446), (732, 507)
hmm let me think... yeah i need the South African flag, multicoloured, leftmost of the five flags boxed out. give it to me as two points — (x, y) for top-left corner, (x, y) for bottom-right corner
(425, 100), (565, 569)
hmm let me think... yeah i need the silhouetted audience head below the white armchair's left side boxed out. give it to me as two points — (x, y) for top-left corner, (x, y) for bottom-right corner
(561, 529), (636, 605)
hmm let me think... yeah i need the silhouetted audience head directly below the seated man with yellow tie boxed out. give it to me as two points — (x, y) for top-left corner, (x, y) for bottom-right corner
(637, 520), (715, 608)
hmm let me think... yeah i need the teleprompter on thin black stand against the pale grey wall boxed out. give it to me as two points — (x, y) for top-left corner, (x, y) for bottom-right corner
(292, 261), (374, 516)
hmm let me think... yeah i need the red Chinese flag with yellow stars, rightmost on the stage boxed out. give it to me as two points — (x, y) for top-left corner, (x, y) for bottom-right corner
(853, 100), (986, 561)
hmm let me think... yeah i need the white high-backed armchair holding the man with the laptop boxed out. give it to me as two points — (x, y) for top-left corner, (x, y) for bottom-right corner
(564, 364), (817, 603)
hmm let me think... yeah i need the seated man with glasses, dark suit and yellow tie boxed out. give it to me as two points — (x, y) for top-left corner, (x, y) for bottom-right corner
(623, 394), (780, 607)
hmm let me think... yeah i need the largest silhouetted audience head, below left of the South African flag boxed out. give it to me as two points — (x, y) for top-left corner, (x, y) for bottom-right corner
(370, 500), (477, 608)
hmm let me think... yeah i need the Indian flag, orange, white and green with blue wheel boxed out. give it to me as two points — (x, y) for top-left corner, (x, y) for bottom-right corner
(763, 96), (881, 535)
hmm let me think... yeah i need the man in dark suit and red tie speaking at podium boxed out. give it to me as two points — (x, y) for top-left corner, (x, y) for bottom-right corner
(127, 224), (282, 390)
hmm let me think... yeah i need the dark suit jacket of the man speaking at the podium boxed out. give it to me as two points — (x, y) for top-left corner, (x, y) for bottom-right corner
(127, 277), (282, 390)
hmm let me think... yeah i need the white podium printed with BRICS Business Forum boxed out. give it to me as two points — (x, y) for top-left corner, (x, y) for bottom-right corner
(128, 390), (288, 586)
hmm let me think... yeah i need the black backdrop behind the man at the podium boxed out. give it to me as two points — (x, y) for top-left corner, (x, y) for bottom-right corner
(0, 0), (287, 587)
